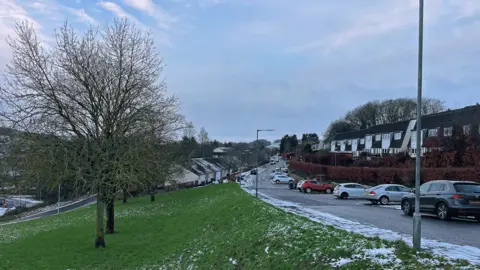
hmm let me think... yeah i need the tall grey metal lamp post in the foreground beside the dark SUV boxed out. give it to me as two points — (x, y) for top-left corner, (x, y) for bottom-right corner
(413, 0), (423, 250)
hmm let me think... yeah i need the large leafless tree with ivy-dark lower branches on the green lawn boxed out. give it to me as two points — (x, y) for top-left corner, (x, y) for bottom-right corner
(0, 20), (183, 247)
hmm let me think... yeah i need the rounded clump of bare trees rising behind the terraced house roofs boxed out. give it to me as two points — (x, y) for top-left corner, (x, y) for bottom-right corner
(323, 97), (446, 142)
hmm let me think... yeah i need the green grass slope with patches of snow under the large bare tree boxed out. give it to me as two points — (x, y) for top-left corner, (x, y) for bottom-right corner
(0, 183), (474, 270)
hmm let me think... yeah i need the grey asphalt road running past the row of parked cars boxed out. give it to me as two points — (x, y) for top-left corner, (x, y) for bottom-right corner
(252, 161), (480, 248)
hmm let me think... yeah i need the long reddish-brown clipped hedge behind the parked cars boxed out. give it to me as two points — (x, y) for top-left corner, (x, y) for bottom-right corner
(289, 160), (480, 187)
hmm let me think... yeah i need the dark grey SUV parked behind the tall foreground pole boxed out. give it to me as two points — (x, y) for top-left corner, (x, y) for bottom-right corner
(402, 180), (480, 222)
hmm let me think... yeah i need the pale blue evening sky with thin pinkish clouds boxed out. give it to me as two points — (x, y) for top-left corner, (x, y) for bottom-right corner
(0, 0), (480, 141)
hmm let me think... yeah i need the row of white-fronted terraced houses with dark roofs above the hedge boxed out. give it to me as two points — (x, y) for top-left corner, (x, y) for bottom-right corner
(316, 104), (480, 157)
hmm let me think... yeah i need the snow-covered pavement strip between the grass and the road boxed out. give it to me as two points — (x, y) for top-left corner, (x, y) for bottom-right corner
(242, 179), (480, 265)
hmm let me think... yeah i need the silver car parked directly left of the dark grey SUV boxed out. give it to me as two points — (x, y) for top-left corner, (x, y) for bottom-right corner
(364, 184), (412, 205)
